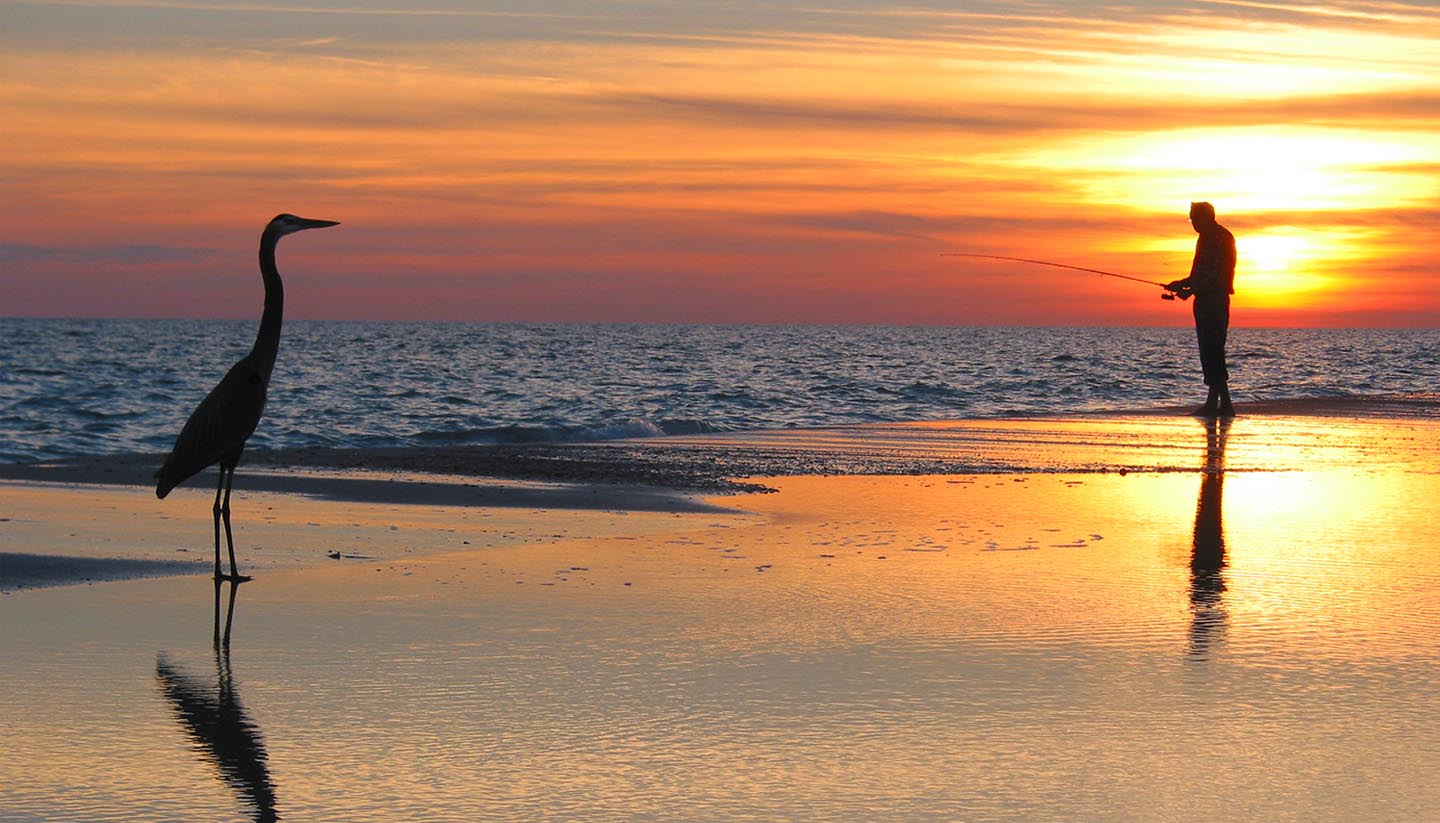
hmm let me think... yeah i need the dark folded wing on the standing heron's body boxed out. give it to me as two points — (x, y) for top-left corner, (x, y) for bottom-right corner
(156, 357), (266, 498)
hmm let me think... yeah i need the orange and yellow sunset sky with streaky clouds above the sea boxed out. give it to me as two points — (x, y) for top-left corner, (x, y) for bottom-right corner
(0, 0), (1440, 327)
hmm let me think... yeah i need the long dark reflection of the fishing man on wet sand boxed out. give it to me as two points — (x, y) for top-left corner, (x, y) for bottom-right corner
(1189, 419), (1230, 659)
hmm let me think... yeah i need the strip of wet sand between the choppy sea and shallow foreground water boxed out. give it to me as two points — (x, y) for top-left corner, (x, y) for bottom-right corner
(0, 406), (1440, 591)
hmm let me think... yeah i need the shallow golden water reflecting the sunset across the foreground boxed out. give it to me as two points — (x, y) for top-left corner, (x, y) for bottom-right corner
(0, 422), (1440, 822)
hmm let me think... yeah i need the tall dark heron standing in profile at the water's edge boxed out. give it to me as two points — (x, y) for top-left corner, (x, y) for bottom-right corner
(156, 214), (338, 583)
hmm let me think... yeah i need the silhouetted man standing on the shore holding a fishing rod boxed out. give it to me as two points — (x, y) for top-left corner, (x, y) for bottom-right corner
(1165, 203), (1236, 417)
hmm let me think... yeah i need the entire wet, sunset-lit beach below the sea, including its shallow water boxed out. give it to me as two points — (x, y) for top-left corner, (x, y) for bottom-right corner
(0, 407), (1440, 822)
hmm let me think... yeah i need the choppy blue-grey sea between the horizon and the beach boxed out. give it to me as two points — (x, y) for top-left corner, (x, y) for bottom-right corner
(0, 319), (1440, 463)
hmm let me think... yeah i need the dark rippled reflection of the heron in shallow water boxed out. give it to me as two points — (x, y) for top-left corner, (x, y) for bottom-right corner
(156, 580), (279, 823)
